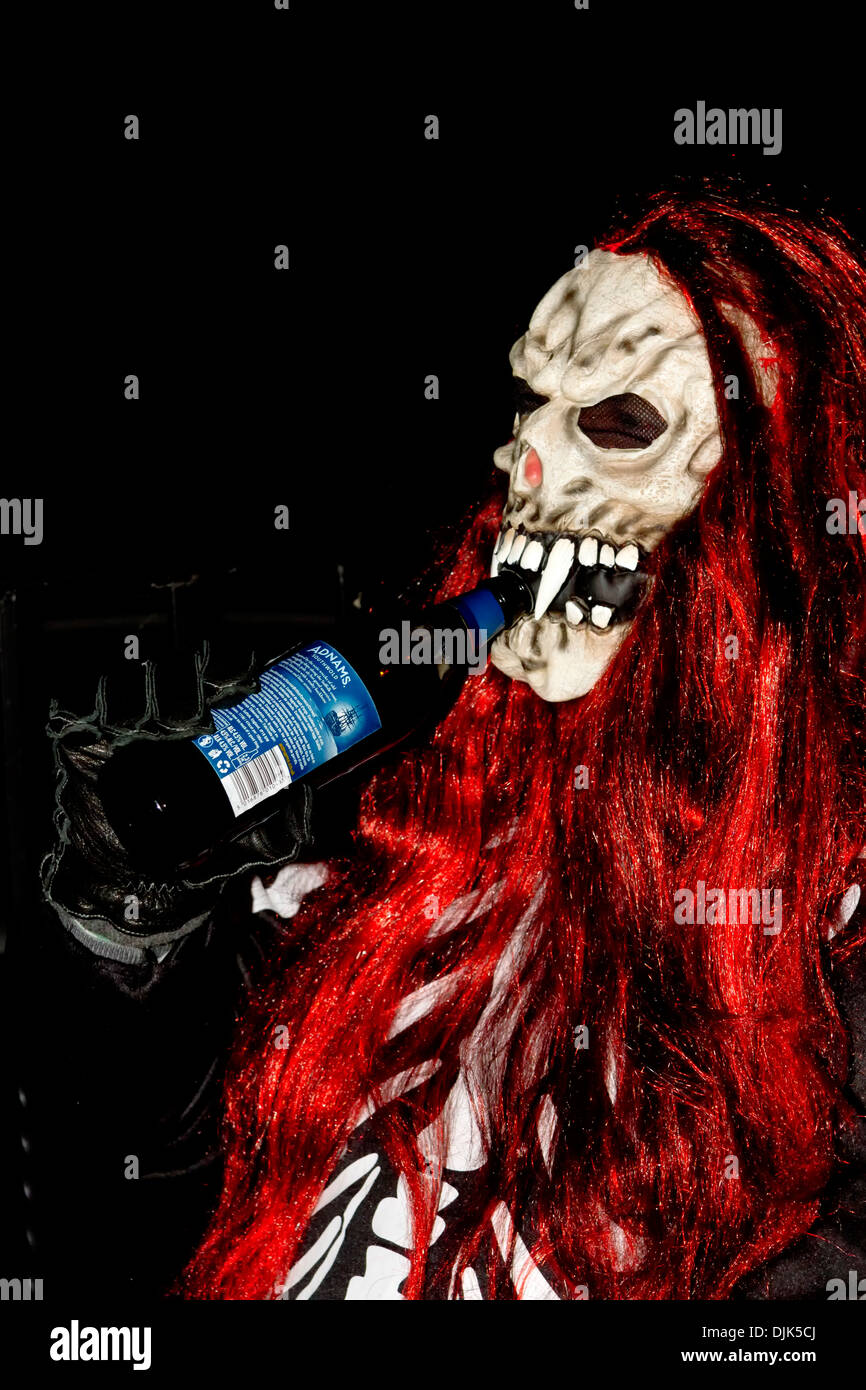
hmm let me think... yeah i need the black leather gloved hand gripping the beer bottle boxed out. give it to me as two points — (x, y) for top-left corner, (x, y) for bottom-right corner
(40, 644), (311, 959)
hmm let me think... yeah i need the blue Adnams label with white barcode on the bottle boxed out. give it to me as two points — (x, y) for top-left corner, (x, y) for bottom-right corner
(195, 642), (382, 816)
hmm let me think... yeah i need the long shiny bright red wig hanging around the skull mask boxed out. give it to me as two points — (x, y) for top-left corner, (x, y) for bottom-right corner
(182, 190), (866, 1298)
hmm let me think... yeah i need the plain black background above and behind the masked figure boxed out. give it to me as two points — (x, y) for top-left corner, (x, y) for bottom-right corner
(0, 0), (863, 1345)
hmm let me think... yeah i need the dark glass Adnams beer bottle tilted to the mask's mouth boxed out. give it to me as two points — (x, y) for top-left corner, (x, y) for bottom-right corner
(99, 571), (532, 870)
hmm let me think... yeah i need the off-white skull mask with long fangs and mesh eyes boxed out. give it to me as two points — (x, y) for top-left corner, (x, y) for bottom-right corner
(491, 250), (721, 701)
